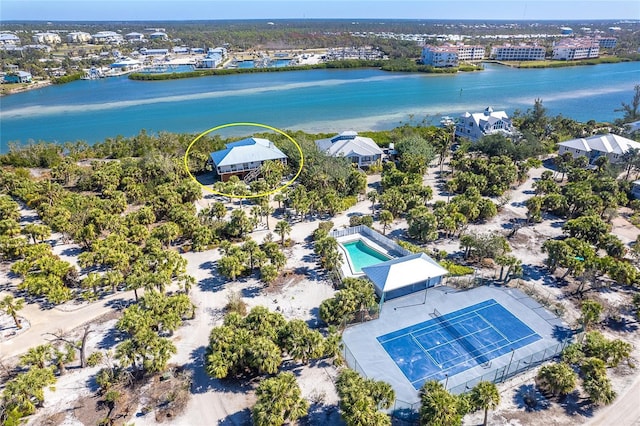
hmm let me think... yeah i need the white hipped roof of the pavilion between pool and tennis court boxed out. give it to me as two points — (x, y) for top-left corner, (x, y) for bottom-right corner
(362, 253), (449, 292)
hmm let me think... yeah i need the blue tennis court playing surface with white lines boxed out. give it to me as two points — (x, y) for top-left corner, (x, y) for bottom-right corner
(377, 299), (541, 390)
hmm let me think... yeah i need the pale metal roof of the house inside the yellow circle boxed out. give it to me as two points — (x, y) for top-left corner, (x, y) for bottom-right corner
(210, 138), (287, 167)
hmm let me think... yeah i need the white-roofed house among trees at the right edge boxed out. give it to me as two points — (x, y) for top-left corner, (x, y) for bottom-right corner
(558, 133), (640, 164)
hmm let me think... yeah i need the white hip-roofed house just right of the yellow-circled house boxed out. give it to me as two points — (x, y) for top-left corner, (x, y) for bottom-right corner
(316, 131), (383, 167)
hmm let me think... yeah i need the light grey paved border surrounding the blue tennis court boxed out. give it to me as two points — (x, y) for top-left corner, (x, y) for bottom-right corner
(342, 286), (570, 403)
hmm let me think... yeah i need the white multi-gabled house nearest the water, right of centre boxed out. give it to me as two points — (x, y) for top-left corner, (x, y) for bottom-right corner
(456, 107), (515, 142)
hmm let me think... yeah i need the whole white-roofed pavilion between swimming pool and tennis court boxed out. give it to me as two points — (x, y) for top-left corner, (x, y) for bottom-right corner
(362, 253), (449, 304)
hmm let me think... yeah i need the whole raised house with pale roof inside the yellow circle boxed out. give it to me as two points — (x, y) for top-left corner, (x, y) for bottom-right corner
(208, 138), (287, 182)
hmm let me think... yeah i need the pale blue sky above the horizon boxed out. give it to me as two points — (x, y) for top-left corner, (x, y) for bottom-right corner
(0, 0), (640, 22)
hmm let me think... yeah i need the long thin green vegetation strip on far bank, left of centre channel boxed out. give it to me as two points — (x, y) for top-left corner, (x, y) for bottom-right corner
(129, 59), (482, 80)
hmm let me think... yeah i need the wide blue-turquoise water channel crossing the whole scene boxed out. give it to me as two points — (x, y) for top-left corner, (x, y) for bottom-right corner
(0, 62), (640, 151)
